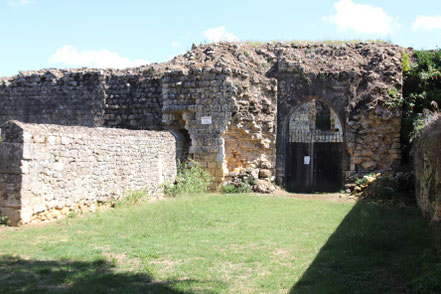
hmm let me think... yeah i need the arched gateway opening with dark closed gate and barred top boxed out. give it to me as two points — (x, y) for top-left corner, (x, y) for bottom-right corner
(284, 98), (344, 192)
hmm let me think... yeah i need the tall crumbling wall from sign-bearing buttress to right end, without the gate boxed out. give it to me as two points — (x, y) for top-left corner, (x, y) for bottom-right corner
(163, 43), (403, 188)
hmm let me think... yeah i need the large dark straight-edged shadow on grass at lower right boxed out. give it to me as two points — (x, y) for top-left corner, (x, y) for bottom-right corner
(290, 202), (441, 293)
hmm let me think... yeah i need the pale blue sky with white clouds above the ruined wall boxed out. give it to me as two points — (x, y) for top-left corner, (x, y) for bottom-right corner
(0, 0), (441, 76)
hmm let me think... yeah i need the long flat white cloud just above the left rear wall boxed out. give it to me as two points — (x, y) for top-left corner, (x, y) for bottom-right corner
(49, 45), (150, 68)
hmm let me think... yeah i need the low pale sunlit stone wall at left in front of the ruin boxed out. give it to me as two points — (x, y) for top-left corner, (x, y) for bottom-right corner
(0, 121), (177, 224)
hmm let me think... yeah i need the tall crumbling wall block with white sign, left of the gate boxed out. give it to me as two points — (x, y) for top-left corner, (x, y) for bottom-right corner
(163, 43), (277, 192)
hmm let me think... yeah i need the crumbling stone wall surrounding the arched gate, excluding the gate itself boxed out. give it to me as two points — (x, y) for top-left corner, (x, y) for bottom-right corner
(274, 43), (403, 182)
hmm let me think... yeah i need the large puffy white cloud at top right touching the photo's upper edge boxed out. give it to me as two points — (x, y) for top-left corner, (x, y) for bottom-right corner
(323, 0), (398, 35)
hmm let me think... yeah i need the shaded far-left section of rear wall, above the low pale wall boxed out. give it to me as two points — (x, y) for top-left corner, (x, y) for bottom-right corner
(0, 70), (104, 126)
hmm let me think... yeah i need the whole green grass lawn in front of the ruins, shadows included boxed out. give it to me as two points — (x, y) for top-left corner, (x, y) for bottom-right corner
(0, 194), (433, 293)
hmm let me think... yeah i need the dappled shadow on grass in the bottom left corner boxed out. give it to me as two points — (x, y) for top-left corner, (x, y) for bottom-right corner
(0, 256), (205, 293)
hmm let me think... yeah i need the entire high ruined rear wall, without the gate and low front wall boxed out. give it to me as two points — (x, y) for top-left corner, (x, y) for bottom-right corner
(0, 43), (402, 198)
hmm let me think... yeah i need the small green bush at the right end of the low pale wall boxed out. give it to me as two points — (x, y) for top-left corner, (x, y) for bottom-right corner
(163, 161), (213, 197)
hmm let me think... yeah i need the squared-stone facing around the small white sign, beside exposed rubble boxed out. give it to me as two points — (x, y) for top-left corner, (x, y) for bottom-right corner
(162, 67), (235, 187)
